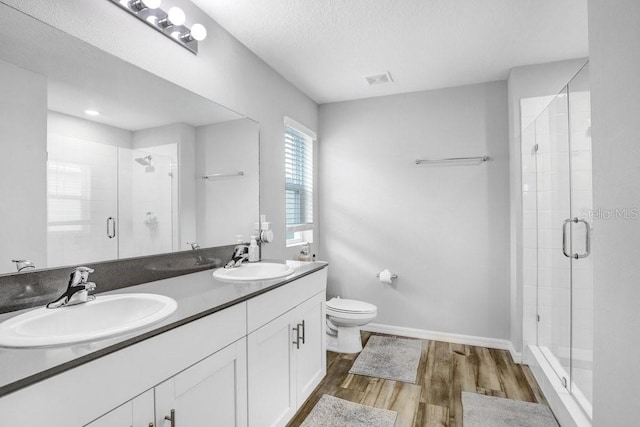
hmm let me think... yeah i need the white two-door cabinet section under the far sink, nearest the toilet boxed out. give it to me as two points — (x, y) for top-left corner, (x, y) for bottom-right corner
(247, 270), (326, 427)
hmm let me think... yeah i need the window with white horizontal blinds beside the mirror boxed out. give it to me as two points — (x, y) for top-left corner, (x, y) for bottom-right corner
(284, 117), (316, 246)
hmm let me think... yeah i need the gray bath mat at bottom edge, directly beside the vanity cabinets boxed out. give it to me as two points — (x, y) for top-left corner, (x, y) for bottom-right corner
(301, 394), (398, 427)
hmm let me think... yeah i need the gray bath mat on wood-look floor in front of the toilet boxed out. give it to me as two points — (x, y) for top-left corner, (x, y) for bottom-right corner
(349, 335), (422, 384)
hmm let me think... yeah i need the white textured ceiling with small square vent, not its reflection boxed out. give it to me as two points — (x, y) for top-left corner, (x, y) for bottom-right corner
(192, 0), (588, 104)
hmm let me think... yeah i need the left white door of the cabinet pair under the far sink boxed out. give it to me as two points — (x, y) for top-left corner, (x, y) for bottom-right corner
(247, 311), (296, 427)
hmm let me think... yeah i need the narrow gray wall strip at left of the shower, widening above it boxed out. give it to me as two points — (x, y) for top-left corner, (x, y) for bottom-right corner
(507, 58), (587, 351)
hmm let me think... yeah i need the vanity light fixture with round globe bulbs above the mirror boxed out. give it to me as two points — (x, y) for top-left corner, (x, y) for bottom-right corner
(109, 0), (207, 55)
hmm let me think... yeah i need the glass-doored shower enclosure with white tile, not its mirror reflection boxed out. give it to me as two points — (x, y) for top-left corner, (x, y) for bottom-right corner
(521, 64), (592, 416)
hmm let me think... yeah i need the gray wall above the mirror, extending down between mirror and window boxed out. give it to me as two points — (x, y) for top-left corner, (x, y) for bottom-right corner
(3, 0), (318, 258)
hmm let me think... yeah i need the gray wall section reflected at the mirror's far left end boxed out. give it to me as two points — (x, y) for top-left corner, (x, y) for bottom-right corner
(0, 61), (47, 273)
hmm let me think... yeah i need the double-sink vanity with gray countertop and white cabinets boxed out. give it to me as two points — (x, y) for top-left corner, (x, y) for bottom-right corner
(0, 261), (327, 427)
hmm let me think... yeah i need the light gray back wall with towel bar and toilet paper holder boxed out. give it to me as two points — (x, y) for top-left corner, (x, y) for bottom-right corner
(319, 82), (509, 339)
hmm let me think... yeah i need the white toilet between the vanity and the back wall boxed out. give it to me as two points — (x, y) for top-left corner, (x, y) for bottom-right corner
(327, 298), (378, 353)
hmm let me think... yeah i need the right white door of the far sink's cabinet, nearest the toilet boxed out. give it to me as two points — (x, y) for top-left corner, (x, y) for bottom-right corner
(293, 292), (327, 405)
